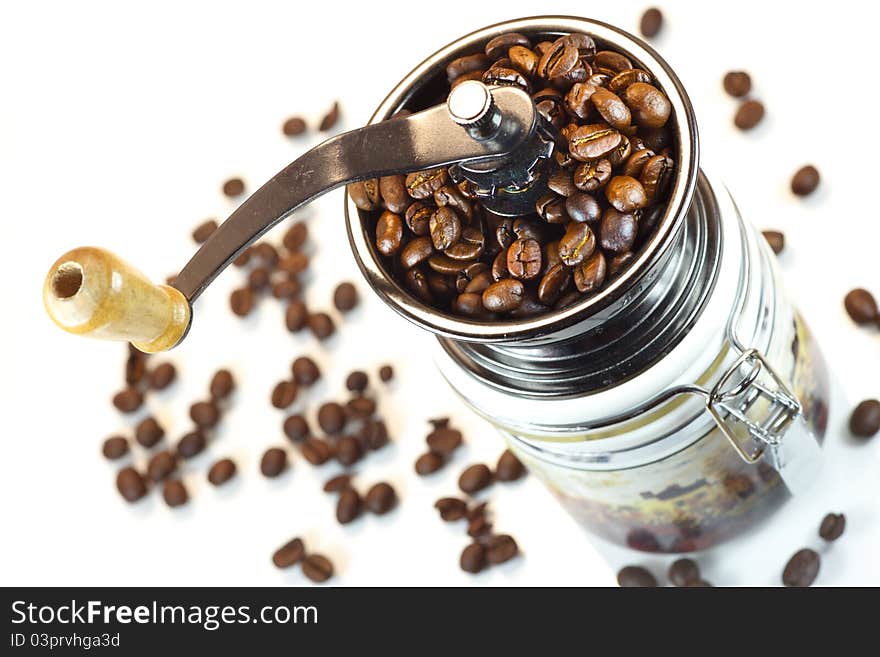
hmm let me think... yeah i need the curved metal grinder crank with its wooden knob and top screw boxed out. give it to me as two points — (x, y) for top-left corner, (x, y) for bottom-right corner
(43, 81), (537, 352)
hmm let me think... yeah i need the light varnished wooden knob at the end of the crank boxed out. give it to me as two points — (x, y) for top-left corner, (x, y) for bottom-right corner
(43, 246), (191, 353)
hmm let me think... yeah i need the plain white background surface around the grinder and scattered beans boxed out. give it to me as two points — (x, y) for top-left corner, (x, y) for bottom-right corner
(0, 0), (880, 585)
